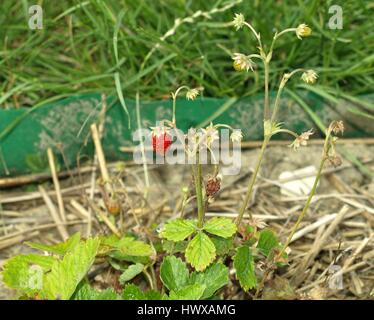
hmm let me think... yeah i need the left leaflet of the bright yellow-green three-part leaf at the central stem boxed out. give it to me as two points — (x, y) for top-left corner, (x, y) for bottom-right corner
(160, 219), (197, 242)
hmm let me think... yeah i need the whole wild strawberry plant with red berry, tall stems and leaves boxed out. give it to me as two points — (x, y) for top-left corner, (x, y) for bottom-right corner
(2, 14), (344, 300)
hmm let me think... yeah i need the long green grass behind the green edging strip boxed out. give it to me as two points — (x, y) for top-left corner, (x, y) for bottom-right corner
(0, 0), (374, 110)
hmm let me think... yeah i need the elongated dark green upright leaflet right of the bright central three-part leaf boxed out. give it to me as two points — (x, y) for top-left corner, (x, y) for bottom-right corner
(234, 246), (257, 291)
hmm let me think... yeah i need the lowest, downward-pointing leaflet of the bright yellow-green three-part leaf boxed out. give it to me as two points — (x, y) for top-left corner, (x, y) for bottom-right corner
(186, 231), (216, 271)
